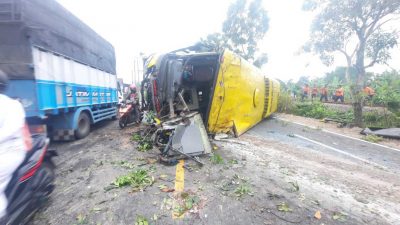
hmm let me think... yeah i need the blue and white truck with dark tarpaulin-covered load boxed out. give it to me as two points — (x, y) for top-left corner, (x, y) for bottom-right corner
(0, 0), (118, 140)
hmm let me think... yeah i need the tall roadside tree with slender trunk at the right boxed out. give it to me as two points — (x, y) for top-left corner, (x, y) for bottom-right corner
(303, 0), (400, 126)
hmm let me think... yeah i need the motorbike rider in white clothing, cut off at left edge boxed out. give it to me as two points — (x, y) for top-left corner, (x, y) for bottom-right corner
(0, 70), (32, 220)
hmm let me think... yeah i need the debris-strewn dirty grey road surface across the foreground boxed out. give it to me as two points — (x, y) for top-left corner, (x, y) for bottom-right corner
(32, 118), (400, 225)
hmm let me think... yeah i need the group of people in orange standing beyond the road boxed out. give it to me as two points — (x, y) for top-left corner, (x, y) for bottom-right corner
(293, 84), (375, 103)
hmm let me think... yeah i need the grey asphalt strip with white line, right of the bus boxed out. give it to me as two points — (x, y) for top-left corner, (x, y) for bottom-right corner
(249, 118), (400, 171)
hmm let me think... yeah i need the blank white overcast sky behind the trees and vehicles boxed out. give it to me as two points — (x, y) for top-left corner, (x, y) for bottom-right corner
(58, 0), (400, 83)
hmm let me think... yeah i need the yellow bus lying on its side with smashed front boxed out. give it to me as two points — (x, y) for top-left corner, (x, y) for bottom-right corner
(141, 48), (280, 136)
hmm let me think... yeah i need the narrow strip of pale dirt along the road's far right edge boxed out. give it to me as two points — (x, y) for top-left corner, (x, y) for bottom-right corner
(275, 113), (400, 149)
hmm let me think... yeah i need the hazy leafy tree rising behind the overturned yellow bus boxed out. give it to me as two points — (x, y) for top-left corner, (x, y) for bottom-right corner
(201, 0), (269, 67)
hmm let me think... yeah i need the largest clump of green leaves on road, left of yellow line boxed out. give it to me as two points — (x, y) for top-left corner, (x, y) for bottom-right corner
(113, 169), (154, 191)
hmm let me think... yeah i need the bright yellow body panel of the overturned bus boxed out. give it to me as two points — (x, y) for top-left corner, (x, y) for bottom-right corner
(208, 50), (279, 136)
